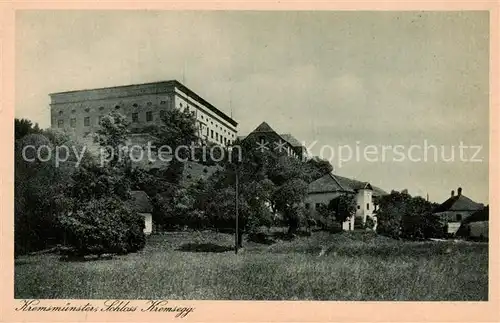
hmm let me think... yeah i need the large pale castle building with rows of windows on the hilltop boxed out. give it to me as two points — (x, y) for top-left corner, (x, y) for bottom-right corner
(50, 80), (238, 146)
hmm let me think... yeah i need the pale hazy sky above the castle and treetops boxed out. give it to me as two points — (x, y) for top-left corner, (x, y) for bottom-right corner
(15, 11), (489, 204)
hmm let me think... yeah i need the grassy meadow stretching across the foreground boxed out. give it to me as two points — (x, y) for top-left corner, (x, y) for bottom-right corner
(15, 232), (488, 301)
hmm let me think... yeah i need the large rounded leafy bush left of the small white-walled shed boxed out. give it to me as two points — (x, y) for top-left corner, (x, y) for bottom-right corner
(59, 197), (145, 256)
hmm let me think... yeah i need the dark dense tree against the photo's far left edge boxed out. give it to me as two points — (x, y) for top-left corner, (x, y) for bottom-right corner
(14, 130), (79, 255)
